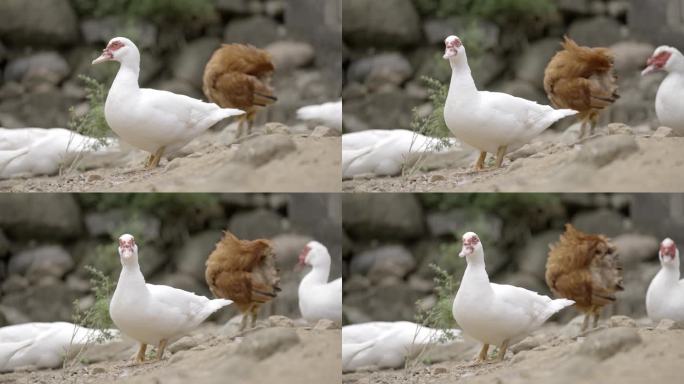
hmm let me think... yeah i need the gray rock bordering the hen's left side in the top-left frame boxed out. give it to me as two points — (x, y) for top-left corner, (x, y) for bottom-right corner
(171, 37), (221, 89)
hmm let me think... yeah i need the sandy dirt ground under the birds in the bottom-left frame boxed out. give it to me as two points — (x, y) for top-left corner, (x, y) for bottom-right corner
(0, 325), (341, 384)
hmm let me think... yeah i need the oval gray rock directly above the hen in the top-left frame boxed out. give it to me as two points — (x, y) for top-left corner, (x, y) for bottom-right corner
(223, 16), (280, 48)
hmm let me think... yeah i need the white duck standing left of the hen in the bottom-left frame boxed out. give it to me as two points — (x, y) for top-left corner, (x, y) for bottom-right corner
(109, 234), (232, 362)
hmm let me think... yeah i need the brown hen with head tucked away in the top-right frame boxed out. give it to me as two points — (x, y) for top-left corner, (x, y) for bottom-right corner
(544, 36), (620, 138)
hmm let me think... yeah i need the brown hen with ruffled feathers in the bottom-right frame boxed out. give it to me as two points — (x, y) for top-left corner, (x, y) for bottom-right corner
(546, 224), (624, 331)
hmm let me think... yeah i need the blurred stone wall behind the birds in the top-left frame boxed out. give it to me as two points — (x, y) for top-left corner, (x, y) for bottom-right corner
(0, 0), (342, 128)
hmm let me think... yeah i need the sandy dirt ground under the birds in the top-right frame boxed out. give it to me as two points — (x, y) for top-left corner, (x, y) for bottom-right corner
(342, 135), (684, 192)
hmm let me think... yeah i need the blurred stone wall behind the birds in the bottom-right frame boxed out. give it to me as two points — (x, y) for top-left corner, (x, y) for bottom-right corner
(342, 193), (684, 326)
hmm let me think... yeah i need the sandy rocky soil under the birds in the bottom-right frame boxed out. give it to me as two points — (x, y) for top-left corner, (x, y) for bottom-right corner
(342, 316), (684, 384)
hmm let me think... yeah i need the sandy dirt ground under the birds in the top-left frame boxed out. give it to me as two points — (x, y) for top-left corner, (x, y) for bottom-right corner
(0, 125), (341, 192)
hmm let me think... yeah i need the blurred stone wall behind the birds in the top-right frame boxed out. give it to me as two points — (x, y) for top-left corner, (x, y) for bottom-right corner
(343, 0), (684, 132)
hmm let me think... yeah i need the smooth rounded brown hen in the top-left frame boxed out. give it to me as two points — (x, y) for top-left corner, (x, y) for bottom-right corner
(202, 44), (277, 137)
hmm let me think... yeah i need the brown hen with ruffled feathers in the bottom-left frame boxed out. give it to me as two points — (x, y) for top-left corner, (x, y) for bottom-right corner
(204, 231), (280, 330)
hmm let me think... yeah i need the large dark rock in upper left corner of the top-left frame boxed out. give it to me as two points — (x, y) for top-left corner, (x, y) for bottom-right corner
(0, 0), (78, 46)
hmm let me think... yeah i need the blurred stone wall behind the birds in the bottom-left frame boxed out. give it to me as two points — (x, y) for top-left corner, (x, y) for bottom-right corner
(0, 194), (342, 326)
